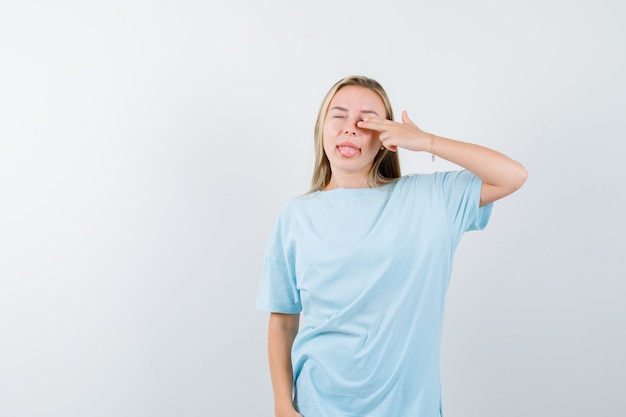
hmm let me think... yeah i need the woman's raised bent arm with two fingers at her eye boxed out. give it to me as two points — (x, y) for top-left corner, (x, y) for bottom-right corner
(359, 111), (528, 206)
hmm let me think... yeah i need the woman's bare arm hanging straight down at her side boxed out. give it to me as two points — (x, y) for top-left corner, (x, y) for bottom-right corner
(268, 313), (300, 417)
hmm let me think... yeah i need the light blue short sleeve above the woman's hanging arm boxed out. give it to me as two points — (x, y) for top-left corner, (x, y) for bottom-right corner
(256, 211), (302, 314)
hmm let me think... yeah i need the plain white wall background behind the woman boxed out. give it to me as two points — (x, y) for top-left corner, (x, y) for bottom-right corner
(0, 0), (626, 417)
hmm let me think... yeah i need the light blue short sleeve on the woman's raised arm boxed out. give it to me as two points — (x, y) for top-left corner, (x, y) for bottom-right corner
(442, 171), (493, 239)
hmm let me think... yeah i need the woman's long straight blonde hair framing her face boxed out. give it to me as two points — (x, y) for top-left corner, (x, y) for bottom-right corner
(309, 75), (400, 192)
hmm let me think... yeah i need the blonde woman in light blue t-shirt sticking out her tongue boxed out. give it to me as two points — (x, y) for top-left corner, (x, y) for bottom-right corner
(257, 76), (527, 417)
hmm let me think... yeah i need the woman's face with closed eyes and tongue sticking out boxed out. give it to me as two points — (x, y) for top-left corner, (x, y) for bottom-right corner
(323, 85), (386, 178)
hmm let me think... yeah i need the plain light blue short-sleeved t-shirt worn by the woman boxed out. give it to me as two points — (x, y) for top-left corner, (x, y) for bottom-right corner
(257, 171), (492, 417)
